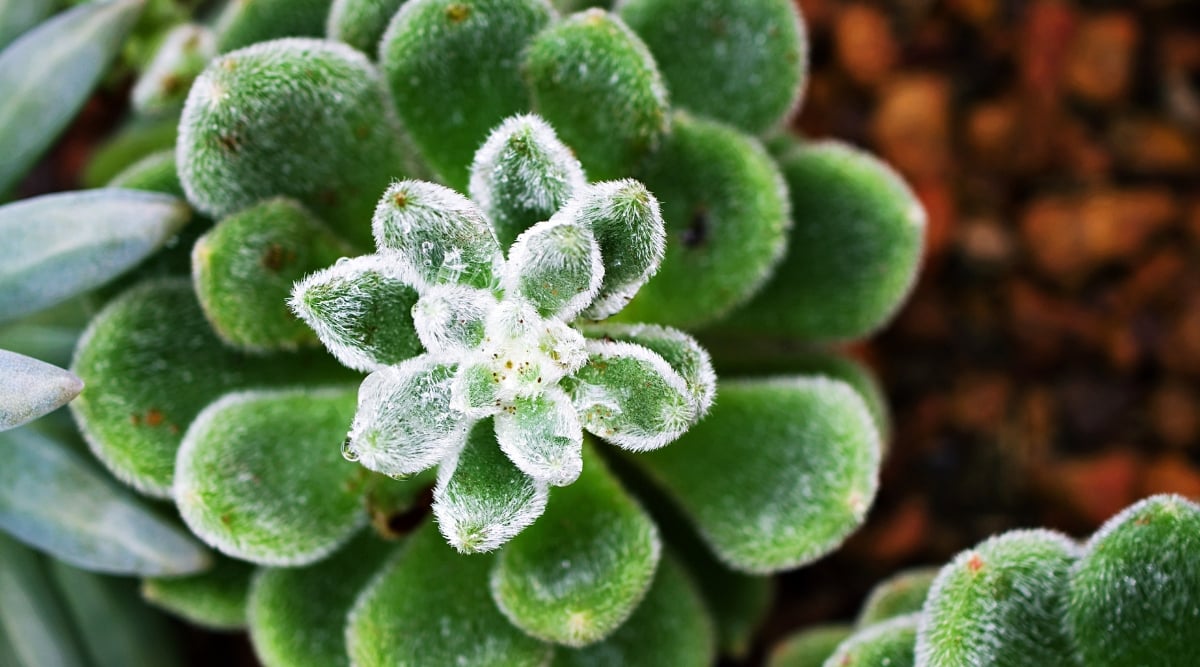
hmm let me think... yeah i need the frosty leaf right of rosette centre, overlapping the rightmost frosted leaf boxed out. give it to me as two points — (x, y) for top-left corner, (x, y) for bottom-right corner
(563, 339), (697, 451)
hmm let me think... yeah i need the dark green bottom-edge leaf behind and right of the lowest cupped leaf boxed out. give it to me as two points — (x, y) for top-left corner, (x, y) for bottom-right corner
(552, 558), (716, 667)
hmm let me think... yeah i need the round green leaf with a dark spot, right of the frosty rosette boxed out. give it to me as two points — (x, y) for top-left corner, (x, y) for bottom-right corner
(620, 113), (792, 329)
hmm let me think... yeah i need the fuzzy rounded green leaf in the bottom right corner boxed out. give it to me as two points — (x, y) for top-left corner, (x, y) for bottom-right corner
(1066, 495), (1200, 667)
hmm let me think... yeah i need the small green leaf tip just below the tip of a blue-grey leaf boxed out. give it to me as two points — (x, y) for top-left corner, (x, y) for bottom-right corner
(142, 557), (254, 630)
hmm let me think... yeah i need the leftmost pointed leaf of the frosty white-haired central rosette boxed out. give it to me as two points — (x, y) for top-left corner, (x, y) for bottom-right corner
(288, 254), (421, 372)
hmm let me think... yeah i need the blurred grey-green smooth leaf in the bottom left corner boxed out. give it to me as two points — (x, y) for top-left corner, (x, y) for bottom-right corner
(0, 533), (88, 667)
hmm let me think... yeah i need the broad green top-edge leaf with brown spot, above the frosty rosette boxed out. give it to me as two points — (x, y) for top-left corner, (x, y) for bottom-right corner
(379, 0), (553, 192)
